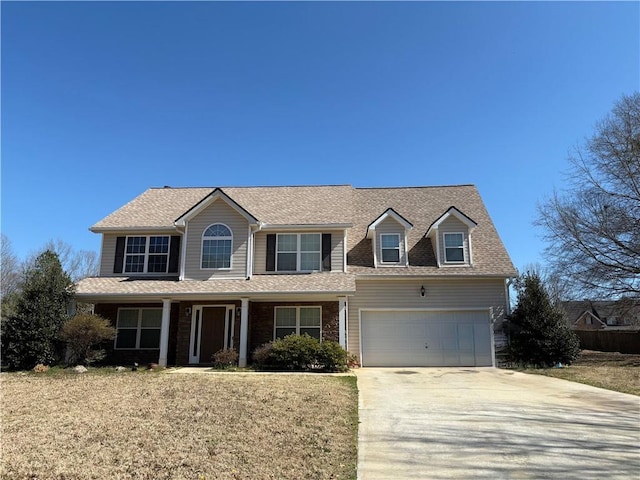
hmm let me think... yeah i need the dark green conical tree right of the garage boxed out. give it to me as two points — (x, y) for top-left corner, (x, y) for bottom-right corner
(505, 273), (580, 367)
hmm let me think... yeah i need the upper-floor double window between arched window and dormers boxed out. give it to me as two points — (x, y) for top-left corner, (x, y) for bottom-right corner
(276, 233), (322, 272)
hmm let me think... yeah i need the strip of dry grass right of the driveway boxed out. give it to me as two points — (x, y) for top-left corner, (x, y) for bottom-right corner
(525, 350), (640, 395)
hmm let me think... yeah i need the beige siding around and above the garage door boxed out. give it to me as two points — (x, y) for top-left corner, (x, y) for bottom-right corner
(347, 279), (507, 355)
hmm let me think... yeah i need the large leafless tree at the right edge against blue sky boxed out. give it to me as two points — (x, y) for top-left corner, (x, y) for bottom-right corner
(537, 93), (640, 298)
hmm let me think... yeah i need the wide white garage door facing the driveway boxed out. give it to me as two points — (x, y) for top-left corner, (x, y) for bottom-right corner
(361, 310), (492, 367)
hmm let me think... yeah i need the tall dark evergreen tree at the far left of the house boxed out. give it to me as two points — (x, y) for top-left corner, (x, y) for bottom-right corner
(2, 250), (73, 369)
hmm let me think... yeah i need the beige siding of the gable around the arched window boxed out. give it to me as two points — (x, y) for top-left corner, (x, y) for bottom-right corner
(185, 200), (249, 280)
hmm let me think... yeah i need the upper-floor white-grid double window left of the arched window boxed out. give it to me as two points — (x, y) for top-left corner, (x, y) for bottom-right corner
(124, 236), (169, 273)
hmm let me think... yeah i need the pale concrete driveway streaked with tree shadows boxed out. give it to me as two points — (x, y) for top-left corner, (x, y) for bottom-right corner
(356, 368), (640, 480)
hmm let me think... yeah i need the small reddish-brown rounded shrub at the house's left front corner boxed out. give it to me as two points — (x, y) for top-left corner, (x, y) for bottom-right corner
(60, 313), (116, 365)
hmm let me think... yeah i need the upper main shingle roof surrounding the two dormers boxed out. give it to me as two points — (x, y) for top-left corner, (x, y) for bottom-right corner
(87, 185), (516, 277)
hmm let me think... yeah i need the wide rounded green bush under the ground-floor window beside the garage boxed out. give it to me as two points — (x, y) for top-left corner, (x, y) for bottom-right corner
(253, 334), (349, 372)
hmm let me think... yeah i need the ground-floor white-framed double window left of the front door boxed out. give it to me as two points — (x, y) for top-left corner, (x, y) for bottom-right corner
(115, 308), (162, 350)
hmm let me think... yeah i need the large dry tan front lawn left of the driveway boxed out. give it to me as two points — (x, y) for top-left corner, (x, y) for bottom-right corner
(0, 372), (357, 480)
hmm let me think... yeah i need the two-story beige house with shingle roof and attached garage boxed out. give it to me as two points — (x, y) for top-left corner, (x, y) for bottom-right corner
(76, 185), (516, 367)
